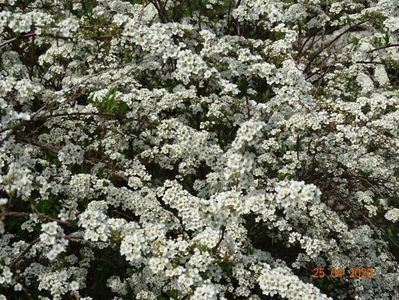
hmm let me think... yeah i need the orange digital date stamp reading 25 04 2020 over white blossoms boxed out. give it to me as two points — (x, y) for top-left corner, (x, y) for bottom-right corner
(312, 267), (374, 279)
